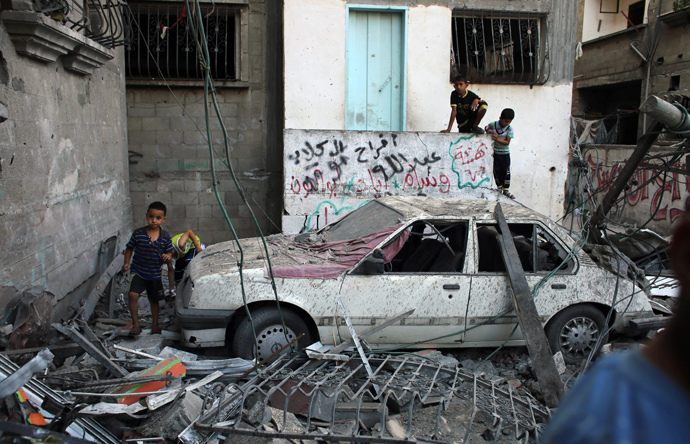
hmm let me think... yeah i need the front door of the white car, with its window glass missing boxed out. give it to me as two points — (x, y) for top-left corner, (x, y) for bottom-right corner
(337, 221), (473, 347)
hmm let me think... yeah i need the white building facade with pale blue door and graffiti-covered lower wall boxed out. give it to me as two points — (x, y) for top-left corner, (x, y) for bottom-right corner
(283, 0), (577, 232)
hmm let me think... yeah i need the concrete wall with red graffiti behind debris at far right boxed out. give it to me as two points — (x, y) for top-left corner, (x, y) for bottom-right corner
(572, 145), (690, 236)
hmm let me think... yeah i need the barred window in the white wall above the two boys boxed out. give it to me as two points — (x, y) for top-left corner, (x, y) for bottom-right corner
(451, 12), (547, 84)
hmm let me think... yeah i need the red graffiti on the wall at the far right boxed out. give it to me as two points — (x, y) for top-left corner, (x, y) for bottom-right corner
(587, 154), (690, 227)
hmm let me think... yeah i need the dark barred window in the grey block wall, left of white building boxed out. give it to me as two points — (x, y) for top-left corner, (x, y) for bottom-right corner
(125, 2), (240, 81)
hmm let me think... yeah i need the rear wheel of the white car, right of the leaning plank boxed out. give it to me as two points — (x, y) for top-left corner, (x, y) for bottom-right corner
(546, 304), (608, 364)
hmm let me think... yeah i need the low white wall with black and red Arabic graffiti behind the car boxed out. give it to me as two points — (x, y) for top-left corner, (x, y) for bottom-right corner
(284, 130), (492, 229)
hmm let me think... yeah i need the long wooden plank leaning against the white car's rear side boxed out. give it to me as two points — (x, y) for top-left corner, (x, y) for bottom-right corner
(494, 203), (563, 407)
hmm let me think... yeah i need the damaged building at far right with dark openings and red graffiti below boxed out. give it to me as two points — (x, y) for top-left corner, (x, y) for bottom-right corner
(573, 0), (690, 235)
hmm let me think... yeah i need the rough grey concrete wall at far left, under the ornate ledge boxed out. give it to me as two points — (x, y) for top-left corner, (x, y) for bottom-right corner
(0, 15), (131, 318)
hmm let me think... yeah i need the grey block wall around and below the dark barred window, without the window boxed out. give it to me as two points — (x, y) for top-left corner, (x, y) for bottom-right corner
(127, 1), (283, 244)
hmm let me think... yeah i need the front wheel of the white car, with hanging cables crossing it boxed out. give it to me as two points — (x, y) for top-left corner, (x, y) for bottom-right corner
(230, 306), (313, 362)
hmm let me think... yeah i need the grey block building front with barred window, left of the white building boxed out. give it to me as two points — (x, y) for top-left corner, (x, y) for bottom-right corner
(124, 0), (283, 244)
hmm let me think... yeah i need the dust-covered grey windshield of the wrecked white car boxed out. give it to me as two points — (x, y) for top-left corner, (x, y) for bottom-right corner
(322, 200), (403, 242)
